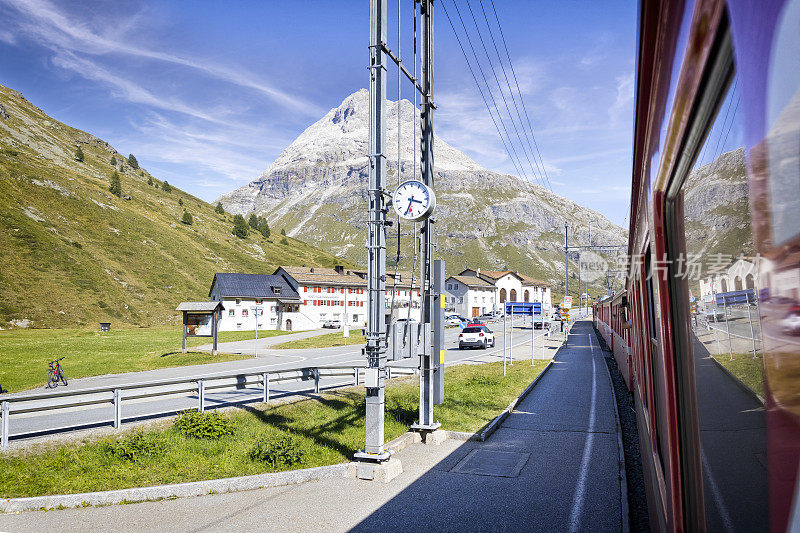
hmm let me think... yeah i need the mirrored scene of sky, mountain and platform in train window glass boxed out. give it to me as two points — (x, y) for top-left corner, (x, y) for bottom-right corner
(676, 71), (768, 531)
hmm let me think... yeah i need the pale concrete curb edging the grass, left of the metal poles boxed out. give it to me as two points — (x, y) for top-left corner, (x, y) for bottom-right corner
(0, 463), (347, 513)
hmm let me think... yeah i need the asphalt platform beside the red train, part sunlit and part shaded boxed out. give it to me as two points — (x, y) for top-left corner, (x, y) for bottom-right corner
(0, 322), (624, 532)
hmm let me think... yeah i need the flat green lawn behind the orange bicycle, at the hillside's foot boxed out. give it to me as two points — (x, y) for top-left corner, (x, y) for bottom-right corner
(0, 326), (286, 392)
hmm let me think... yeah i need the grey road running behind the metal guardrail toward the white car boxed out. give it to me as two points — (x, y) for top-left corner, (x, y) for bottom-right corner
(3, 316), (560, 445)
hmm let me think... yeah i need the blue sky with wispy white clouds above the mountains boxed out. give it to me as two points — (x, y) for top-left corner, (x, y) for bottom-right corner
(0, 0), (636, 227)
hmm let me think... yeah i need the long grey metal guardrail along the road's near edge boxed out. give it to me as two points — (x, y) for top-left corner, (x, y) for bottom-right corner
(0, 366), (417, 449)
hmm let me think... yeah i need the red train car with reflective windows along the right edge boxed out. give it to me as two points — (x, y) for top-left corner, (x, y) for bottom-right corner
(620, 0), (800, 531)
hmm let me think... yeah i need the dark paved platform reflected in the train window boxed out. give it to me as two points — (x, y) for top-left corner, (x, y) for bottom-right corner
(694, 334), (769, 531)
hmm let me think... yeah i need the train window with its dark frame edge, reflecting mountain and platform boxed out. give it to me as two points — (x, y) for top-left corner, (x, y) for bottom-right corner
(664, 33), (768, 531)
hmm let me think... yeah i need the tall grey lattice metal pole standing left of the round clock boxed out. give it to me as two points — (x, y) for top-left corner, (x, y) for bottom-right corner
(364, 0), (388, 460)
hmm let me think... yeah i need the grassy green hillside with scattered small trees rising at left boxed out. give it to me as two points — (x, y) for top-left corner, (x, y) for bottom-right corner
(0, 85), (350, 328)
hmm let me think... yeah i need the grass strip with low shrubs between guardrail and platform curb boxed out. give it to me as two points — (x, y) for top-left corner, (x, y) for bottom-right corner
(0, 361), (546, 497)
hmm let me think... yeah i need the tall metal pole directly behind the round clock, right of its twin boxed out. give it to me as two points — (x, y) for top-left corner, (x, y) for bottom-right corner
(412, 0), (438, 430)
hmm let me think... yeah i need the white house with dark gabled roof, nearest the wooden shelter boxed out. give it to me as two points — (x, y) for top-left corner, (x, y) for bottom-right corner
(208, 272), (300, 331)
